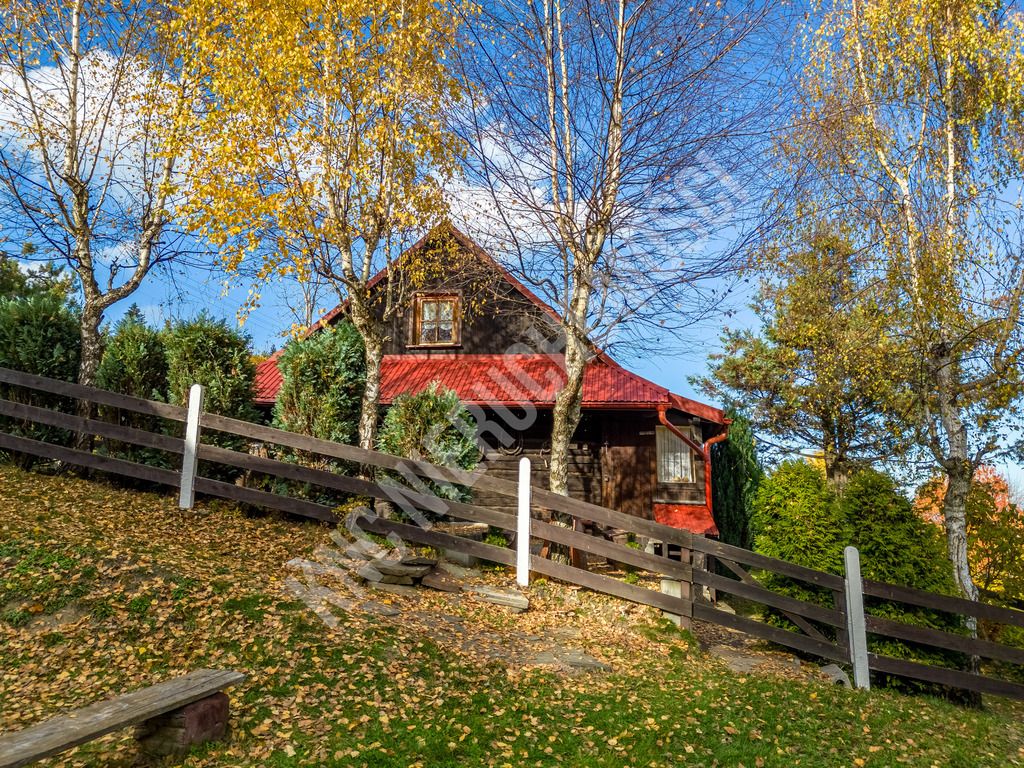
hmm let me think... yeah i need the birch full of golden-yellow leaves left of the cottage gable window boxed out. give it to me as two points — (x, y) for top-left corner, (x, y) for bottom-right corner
(175, 0), (468, 449)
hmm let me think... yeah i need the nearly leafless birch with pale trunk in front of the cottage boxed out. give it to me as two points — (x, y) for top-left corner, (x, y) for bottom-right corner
(466, 0), (772, 494)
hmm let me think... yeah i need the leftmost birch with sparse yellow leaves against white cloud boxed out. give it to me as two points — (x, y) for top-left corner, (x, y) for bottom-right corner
(0, 0), (191, 385)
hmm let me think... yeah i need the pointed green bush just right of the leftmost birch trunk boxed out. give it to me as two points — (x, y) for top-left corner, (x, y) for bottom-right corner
(96, 305), (171, 475)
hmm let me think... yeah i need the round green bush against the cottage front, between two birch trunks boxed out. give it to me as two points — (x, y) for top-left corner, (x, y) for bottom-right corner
(377, 382), (480, 518)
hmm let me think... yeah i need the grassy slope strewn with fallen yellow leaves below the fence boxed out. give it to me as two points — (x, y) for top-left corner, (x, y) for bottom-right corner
(0, 467), (1024, 768)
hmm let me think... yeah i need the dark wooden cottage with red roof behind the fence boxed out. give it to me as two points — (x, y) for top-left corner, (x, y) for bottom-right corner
(256, 226), (728, 536)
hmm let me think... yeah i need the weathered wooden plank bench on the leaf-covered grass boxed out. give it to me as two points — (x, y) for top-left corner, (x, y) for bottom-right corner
(0, 670), (246, 768)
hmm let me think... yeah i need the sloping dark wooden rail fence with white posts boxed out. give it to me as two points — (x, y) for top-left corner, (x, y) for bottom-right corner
(0, 369), (1024, 699)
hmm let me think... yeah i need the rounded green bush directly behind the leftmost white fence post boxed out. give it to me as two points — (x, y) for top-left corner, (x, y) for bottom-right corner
(163, 312), (259, 480)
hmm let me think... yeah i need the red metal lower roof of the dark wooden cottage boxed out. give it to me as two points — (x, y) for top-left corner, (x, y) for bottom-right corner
(256, 354), (725, 424)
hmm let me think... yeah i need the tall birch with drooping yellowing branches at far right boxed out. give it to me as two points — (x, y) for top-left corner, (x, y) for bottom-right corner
(783, 0), (1024, 599)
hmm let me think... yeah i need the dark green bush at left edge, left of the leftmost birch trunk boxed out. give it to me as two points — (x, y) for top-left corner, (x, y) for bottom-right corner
(0, 293), (82, 469)
